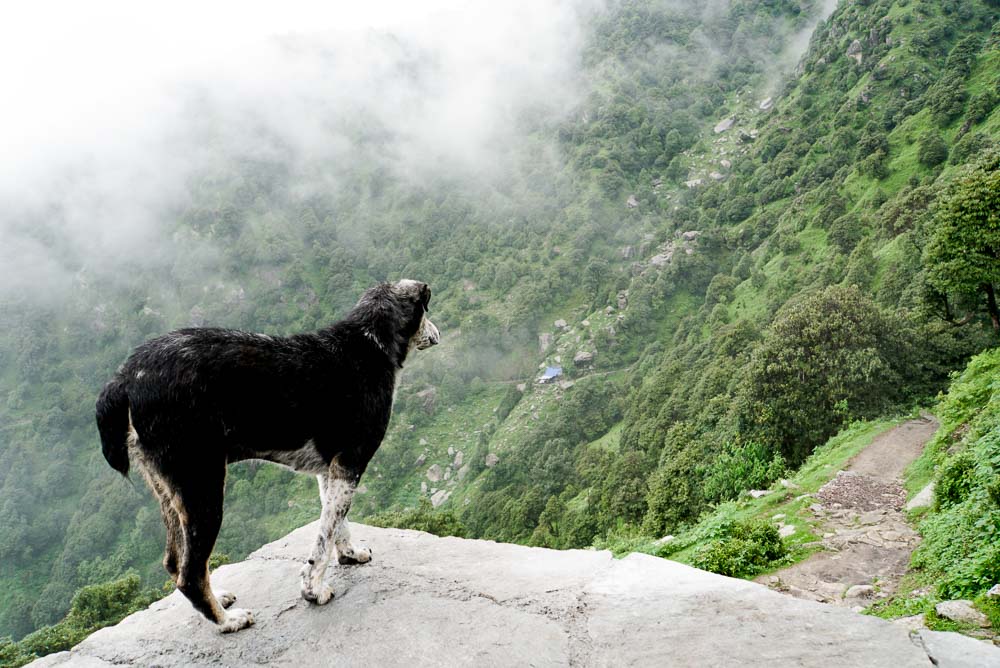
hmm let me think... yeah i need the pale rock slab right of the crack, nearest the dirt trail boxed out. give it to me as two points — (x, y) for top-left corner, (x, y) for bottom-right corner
(586, 554), (929, 668)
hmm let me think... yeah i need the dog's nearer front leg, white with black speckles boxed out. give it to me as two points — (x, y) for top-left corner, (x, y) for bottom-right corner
(302, 464), (371, 605)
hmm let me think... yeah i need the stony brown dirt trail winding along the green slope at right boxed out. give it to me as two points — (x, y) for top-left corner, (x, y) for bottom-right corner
(758, 417), (938, 608)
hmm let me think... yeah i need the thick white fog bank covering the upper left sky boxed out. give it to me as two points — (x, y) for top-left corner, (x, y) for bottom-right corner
(0, 0), (600, 298)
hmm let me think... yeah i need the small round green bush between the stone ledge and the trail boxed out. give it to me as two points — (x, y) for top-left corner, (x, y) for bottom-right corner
(691, 520), (788, 577)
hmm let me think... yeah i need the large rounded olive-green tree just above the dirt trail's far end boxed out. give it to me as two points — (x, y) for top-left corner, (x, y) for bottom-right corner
(739, 286), (919, 466)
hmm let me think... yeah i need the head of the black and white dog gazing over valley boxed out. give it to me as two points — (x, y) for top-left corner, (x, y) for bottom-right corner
(354, 278), (441, 366)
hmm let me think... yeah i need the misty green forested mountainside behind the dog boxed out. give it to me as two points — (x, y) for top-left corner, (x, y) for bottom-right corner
(0, 0), (1000, 652)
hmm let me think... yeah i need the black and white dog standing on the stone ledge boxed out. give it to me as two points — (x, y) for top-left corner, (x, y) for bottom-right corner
(97, 280), (440, 633)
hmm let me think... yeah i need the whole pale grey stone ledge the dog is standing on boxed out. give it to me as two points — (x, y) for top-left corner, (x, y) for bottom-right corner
(33, 524), (1000, 668)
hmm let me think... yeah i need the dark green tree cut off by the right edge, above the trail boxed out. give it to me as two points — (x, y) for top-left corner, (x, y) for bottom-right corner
(924, 153), (1000, 334)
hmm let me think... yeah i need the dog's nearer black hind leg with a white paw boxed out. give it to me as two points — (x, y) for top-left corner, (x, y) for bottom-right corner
(174, 464), (254, 633)
